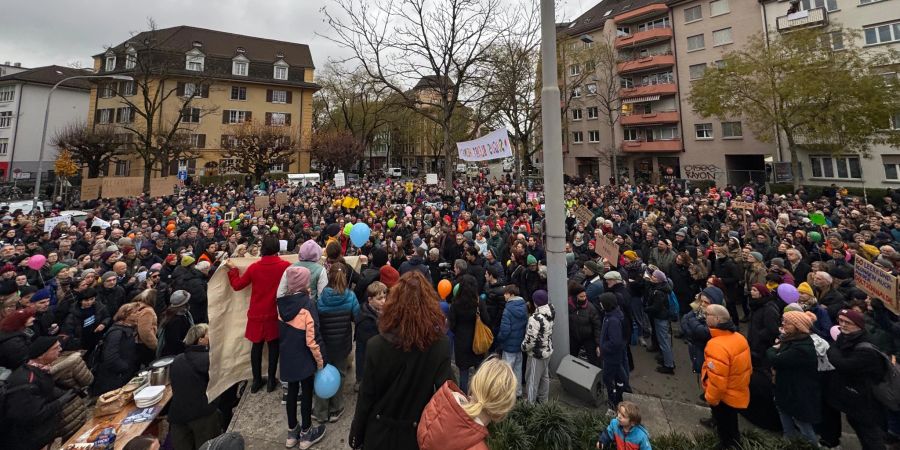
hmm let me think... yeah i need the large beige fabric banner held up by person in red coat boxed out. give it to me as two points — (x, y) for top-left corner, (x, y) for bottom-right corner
(206, 254), (359, 399)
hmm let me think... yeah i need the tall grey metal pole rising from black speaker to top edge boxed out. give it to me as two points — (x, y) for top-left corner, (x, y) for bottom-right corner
(541, 0), (569, 372)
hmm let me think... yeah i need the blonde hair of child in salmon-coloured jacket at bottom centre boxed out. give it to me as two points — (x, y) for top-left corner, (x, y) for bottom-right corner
(462, 357), (518, 422)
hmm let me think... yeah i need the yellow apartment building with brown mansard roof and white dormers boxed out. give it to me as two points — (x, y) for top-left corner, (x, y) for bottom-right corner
(88, 26), (319, 176)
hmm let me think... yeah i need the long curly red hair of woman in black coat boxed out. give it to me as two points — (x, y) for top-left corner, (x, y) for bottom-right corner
(378, 270), (446, 351)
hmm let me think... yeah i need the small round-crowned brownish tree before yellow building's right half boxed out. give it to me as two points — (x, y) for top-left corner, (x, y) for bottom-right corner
(222, 121), (298, 183)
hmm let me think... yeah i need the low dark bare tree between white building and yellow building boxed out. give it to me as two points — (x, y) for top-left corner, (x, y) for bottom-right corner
(51, 122), (127, 178)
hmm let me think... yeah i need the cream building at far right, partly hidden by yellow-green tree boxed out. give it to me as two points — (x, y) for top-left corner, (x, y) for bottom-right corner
(758, 0), (900, 187)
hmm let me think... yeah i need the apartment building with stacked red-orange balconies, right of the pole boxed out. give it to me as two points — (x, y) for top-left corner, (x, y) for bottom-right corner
(558, 0), (772, 184)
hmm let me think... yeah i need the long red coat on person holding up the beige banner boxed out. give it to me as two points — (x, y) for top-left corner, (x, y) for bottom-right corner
(228, 255), (291, 343)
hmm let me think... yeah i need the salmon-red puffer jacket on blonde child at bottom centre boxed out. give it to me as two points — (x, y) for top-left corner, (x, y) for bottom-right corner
(416, 381), (488, 450)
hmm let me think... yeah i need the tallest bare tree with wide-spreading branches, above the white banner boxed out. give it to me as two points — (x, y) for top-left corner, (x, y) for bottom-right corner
(323, 0), (501, 188)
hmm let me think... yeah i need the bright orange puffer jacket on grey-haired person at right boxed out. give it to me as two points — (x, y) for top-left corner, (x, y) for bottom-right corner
(700, 328), (753, 408)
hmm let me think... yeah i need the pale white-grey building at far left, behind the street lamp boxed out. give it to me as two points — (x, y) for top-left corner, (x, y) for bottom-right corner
(0, 66), (91, 183)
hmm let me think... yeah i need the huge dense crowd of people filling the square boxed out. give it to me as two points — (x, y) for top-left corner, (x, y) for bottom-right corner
(0, 179), (900, 450)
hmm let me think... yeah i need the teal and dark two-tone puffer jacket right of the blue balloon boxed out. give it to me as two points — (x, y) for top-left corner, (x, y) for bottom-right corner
(316, 287), (359, 361)
